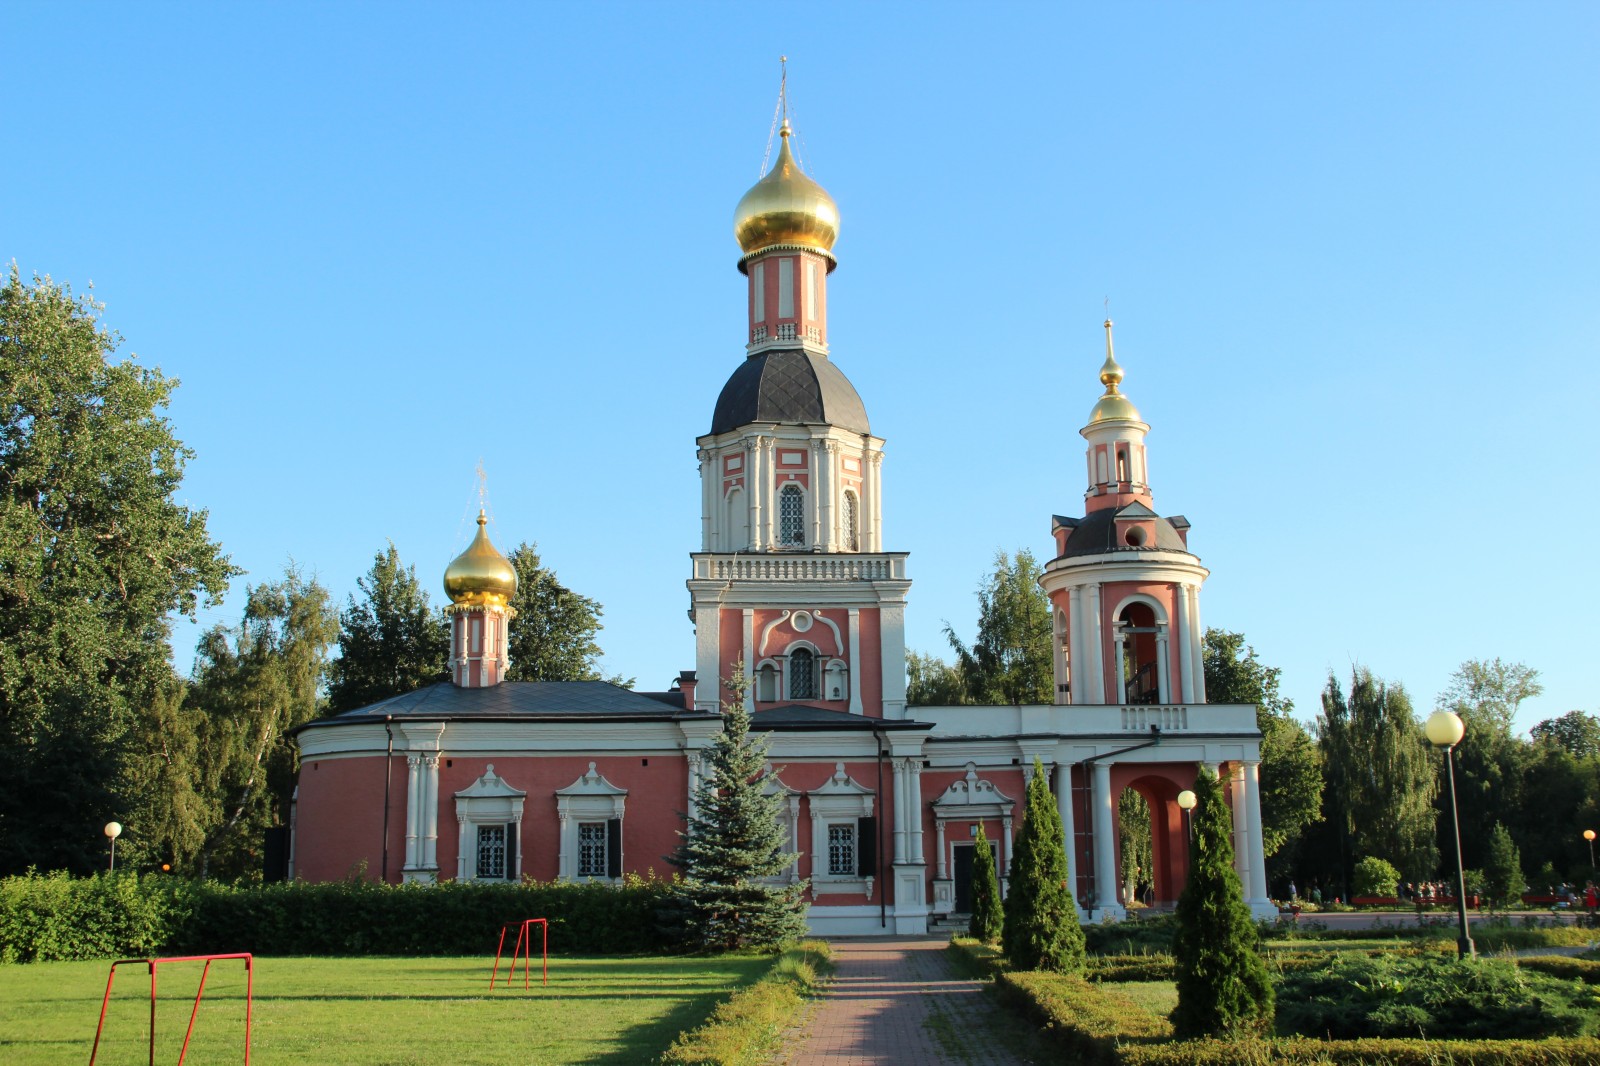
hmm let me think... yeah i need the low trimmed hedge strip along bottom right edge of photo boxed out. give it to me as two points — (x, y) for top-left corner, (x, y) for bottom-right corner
(1122, 1039), (1600, 1066)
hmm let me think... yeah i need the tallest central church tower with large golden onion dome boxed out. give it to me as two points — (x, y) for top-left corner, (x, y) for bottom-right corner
(688, 118), (910, 717)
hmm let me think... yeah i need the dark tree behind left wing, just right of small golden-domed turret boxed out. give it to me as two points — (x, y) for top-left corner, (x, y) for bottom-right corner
(506, 543), (634, 688)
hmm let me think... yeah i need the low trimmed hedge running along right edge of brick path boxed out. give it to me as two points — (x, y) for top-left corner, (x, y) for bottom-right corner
(995, 972), (1173, 1066)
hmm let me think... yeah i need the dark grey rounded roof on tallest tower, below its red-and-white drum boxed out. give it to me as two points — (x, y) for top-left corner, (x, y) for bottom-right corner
(710, 347), (872, 434)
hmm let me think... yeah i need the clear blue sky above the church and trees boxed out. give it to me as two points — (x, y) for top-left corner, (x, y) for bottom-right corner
(0, 0), (1600, 739)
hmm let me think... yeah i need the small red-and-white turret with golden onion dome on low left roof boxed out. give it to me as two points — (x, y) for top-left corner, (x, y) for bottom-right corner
(445, 511), (517, 688)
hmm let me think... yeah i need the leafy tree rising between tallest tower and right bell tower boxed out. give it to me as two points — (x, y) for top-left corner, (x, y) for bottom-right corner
(944, 547), (1056, 704)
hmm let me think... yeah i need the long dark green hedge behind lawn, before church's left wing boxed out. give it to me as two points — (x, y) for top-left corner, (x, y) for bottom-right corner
(0, 874), (672, 962)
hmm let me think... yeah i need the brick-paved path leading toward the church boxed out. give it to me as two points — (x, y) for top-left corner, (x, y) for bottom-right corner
(778, 936), (1024, 1066)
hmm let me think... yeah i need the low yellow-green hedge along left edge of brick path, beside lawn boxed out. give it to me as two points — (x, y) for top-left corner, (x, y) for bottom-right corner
(661, 940), (832, 1066)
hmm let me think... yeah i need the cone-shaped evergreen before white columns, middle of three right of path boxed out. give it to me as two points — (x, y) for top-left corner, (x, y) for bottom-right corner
(1000, 759), (1085, 973)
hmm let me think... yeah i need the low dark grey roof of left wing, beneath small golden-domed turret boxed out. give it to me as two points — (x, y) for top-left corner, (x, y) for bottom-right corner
(301, 682), (714, 728)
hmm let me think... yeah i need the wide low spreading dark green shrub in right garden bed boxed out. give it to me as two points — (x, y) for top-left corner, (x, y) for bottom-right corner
(1277, 952), (1597, 1040)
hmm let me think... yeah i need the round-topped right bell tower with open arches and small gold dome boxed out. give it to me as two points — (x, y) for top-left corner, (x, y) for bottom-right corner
(1038, 320), (1210, 706)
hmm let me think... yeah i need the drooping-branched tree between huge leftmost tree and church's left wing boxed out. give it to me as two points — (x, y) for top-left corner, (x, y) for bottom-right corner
(190, 568), (339, 877)
